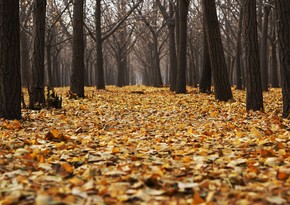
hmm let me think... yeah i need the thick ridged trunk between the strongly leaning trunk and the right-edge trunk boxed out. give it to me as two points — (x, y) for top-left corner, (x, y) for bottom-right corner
(242, 0), (264, 111)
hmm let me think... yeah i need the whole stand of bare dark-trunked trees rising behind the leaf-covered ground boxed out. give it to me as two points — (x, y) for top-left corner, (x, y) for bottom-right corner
(0, 0), (290, 119)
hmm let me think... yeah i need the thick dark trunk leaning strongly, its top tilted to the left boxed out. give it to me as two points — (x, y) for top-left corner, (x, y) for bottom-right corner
(202, 0), (233, 101)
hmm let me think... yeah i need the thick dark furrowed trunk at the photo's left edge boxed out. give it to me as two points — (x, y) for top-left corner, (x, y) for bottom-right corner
(0, 0), (21, 119)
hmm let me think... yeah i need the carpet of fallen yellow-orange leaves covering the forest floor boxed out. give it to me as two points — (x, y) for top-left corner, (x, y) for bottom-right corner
(0, 86), (290, 205)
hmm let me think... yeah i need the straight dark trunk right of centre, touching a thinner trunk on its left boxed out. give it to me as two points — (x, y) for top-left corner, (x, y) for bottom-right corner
(176, 0), (189, 93)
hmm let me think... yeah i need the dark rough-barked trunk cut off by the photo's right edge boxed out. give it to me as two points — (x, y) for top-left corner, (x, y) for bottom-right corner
(275, 0), (290, 118)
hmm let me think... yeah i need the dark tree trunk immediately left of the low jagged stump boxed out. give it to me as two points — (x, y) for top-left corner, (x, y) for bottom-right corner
(29, 0), (46, 109)
